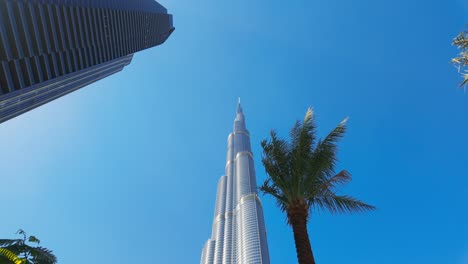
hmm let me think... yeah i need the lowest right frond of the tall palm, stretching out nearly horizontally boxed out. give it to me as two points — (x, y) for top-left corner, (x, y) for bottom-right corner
(313, 195), (376, 213)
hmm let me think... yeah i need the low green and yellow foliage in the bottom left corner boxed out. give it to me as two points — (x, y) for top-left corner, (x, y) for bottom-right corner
(0, 229), (57, 264)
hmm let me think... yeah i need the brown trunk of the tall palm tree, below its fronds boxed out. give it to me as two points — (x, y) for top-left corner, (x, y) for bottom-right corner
(289, 213), (315, 264)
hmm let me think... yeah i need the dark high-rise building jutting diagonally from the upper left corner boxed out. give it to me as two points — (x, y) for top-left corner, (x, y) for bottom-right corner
(0, 0), (174, 123)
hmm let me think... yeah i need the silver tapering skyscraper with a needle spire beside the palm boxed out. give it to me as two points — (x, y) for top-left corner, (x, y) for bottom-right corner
(200, 102), (270, 264)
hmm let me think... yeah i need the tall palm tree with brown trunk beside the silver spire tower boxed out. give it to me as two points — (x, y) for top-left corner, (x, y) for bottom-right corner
(260, 108), (375, 264)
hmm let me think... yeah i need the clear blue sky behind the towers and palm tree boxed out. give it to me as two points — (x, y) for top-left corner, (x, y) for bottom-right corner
(0, 0), (468, 264)
